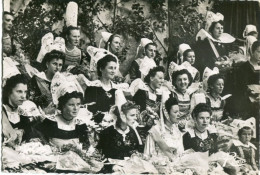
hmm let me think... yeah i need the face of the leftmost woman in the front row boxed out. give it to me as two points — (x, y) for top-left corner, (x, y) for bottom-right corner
(9, 83), (27, 106)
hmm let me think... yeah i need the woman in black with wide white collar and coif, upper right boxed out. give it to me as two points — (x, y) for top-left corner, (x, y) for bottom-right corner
(195, 11), (235, 75)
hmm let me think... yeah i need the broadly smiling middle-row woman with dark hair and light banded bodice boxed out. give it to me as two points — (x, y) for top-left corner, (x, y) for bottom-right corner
(172, 69), (192, 128)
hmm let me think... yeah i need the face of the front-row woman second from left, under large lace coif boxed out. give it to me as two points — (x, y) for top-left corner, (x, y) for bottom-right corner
(62, 98), (81, 121)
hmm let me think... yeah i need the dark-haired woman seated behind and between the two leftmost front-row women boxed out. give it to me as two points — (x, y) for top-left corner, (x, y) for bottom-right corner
(29, 50), (65, 113)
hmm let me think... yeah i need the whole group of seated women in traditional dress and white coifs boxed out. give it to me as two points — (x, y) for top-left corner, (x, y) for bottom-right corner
(2, 8), (260, 175)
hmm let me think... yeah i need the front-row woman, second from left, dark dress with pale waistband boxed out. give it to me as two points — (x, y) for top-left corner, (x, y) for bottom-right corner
(37, 89), (89, 148)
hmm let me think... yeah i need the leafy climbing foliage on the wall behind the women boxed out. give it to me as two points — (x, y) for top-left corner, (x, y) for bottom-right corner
(10, 0), (211, 72)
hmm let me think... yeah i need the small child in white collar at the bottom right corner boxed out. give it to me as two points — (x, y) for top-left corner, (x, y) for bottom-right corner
(230, 126), (258, 171)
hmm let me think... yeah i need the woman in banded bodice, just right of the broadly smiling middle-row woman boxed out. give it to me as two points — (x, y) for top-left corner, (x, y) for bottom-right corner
(206, 74), (225, 121)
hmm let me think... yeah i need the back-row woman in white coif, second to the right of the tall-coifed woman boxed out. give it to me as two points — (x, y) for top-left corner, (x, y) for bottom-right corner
(129, 38), (157, 81)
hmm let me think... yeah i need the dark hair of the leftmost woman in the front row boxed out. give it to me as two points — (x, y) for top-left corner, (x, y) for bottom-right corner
(2, 74), (28, 104)
